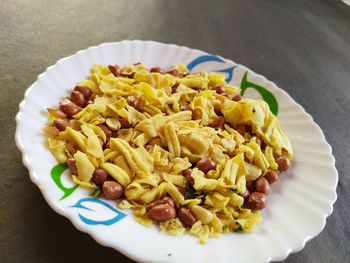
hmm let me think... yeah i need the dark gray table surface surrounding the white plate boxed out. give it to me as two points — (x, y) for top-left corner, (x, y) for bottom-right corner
(0, 0), (350, 262)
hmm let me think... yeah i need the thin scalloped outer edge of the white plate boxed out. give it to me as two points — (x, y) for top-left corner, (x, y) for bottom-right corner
(15, 39), (339, 261)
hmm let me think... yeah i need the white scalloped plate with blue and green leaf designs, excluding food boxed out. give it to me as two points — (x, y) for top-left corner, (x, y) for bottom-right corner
(16, 40), (338, 262)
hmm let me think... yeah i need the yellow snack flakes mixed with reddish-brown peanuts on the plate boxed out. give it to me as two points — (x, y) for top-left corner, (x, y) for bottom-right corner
(44, 63), (293, 243)
